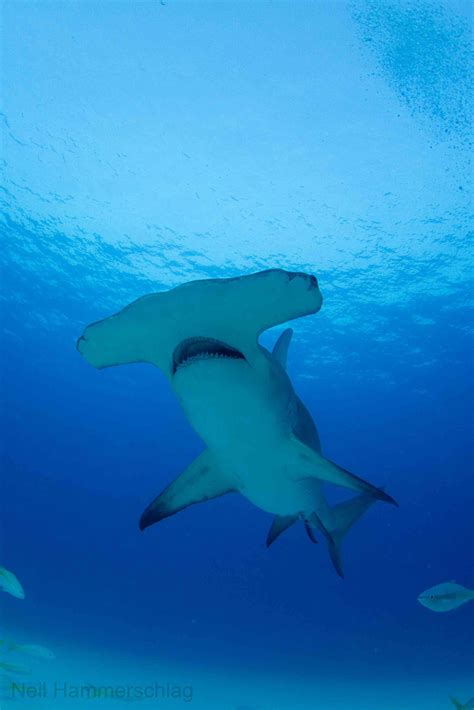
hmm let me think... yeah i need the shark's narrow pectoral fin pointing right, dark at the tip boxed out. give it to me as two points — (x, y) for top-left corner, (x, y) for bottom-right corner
(292, 437), (398, 505)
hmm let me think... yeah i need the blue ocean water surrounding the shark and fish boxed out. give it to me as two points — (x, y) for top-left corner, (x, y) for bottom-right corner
(0, 0), (474, 710)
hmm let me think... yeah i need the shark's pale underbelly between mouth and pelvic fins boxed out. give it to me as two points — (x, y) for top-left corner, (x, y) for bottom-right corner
(175, 359), (326, 515)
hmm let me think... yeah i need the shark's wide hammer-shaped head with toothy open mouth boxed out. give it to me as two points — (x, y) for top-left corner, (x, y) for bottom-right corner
(77, 269), (322, 380)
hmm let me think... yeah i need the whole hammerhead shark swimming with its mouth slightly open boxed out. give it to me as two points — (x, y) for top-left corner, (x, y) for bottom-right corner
(77, 269), (397, 577)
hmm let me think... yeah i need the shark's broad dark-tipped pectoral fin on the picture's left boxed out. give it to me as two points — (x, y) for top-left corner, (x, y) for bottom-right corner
(140, 449), (237, 530)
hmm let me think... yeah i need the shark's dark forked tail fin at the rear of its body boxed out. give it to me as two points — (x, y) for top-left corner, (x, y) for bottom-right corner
(308, 493), (377, 577)
